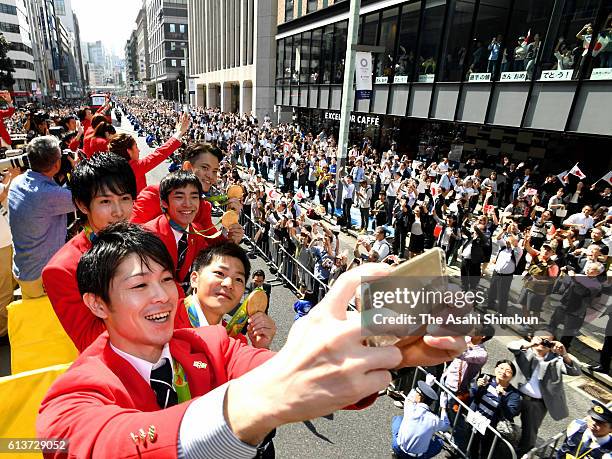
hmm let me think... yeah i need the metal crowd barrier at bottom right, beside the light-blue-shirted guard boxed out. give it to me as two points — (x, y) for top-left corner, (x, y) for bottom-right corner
(411, 367), (517, 459)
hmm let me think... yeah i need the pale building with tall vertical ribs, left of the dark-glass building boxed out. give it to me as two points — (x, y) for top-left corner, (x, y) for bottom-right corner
(189, 0), (277, 119)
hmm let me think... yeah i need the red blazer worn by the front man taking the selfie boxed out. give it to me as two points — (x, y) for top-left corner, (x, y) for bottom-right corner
(36, 326), (274, 459)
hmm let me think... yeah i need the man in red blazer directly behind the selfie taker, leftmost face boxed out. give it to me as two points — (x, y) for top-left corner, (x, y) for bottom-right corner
(42, 153), (189, 352)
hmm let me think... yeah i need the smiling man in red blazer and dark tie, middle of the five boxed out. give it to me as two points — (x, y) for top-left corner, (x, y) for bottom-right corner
(144, 171), (214, 293)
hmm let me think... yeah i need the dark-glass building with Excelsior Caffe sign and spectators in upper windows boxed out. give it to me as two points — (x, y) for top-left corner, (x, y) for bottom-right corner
(275, 0), (612, 170)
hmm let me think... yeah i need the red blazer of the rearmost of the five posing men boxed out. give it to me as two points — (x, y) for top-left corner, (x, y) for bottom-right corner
(130, 184), (227, 245)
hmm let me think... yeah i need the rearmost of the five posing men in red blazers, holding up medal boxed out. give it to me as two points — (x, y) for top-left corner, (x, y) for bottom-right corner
(130, 143), (244, 244)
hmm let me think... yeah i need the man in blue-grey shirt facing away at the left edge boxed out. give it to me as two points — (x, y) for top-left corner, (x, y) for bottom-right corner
(8, 136), (75, 299)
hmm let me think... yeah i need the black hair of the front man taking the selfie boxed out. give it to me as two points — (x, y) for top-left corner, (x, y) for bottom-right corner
(77, 222), (174, 303)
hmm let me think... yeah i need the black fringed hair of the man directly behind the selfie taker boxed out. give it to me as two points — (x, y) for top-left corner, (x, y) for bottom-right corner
(70, 153), (136, 208)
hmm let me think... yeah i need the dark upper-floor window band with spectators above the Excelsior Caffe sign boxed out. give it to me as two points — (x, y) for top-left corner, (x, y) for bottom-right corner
(276, 0), (612, 86)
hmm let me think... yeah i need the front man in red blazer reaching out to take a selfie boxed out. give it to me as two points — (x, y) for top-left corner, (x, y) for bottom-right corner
(36, 223), (465, 458)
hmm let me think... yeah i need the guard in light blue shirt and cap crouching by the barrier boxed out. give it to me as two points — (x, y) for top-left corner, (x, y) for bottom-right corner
(391, 381), (450, 459)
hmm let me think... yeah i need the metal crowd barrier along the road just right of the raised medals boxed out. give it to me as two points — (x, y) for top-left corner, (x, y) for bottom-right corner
(240, 212), (338, 310)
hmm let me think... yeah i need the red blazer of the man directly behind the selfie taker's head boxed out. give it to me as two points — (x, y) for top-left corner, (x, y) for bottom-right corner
(42, 232), (190, 352)
